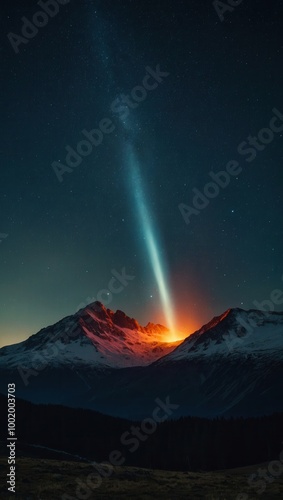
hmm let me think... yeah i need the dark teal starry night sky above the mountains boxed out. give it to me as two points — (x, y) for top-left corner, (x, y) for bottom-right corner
(0, 0), (283, 346)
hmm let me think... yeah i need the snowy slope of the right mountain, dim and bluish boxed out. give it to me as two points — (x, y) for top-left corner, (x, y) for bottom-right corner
(159, 309), (283, 363)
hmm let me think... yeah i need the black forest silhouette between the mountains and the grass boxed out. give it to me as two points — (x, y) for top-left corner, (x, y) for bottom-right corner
(0, 395), (283, 471)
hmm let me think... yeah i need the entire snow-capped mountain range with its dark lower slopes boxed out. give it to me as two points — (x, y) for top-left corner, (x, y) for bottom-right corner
(0, 302), (283, 419)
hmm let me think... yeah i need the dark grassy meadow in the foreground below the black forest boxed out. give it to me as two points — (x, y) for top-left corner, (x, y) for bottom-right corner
(0, 457), (283, 500)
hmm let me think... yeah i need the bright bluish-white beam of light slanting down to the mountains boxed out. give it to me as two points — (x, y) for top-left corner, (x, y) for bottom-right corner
(126, 144), (175, 335)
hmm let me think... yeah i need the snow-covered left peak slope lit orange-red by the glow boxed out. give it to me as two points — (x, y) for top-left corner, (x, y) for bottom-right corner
(0, 302), (180, 368)
